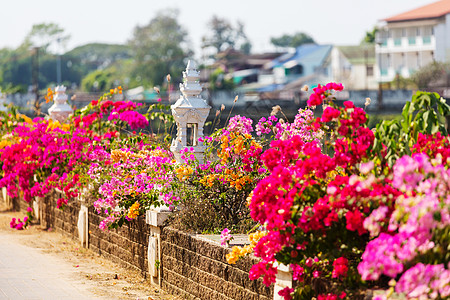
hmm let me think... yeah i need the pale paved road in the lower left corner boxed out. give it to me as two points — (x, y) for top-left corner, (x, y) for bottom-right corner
(0, 231), (105, 300)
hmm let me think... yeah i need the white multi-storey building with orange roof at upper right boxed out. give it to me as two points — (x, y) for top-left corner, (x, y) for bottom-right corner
(376, 0), (450, 82)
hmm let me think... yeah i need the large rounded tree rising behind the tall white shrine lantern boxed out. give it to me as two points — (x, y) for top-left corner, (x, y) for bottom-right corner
(129, 10), (192, 85)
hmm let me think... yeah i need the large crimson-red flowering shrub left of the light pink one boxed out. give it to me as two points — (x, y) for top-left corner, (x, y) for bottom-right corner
(250, 102), (374, 299)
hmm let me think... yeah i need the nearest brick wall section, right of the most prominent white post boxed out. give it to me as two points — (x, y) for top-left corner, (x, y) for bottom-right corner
(161, 227), (273, 300)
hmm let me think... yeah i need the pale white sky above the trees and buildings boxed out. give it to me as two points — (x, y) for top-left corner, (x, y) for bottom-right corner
(0, 0), (434, 55)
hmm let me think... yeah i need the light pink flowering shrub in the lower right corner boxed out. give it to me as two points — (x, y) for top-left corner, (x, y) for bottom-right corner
(358, 154), (450, 299)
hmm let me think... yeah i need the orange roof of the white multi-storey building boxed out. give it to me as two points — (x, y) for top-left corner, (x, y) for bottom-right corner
(384, 0), (450, 22)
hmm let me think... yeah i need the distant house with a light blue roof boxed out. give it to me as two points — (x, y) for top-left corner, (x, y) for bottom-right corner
(259, 44), (332, 84)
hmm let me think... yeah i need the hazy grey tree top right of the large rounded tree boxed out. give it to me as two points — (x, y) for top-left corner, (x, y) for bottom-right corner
(202, 16), (251, 54)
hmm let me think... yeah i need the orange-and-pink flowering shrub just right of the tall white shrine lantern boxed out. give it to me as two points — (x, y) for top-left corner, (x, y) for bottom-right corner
(171, 116), (266, 232)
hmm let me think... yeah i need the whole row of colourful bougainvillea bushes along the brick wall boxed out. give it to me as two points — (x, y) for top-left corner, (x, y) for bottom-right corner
(0, 79), (450, 299)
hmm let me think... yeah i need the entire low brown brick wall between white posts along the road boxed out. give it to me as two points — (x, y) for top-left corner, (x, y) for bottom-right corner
(37, 192), (273, 300)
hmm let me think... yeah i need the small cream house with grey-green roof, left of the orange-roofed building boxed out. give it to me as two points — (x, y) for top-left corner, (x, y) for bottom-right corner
(326, 44), (378, 90)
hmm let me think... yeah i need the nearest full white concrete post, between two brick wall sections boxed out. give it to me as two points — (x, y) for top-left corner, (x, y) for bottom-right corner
(145, 206), (171, 286)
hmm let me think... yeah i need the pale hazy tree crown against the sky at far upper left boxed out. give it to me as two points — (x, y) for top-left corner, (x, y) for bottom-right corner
(21, 23), (70, 52)
